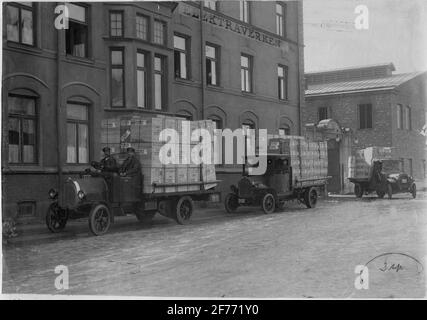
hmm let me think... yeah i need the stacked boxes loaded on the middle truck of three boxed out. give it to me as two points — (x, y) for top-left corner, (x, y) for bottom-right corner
(268, 135), (328, 181)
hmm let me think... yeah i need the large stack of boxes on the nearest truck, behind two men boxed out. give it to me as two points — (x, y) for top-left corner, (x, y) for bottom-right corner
(101, 116), (216, 193)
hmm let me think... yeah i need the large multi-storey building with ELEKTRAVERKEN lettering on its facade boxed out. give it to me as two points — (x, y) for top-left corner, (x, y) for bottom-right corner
(2, 1), (304, 219)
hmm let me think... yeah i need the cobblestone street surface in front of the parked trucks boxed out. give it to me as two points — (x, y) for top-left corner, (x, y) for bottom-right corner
(3, 194), (427, 298)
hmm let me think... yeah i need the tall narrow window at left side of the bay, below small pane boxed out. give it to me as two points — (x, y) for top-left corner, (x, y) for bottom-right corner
(110, 48), (125, 107)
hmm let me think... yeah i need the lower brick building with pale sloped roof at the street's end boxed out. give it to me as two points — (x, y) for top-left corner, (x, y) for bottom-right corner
(302, 63), (427, 192)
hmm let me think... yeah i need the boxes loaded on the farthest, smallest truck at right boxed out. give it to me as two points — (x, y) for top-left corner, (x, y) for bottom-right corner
(349, 146), (391, 179)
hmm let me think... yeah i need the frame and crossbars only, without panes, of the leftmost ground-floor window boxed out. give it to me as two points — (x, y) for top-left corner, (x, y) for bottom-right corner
(7, 93), (39, 166)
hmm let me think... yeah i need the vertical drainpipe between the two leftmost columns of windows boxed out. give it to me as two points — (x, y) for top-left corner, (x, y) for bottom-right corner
(55, 8), (65, 196)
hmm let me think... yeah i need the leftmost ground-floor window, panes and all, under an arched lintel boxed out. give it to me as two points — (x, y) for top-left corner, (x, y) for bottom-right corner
(8, 95), (37, 164)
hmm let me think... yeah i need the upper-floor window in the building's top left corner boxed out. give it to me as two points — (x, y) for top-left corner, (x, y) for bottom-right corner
(6, 2), (35, 46)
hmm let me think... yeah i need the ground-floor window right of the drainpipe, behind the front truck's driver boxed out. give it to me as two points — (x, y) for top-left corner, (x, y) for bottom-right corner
(67, 102), (89, 163)
